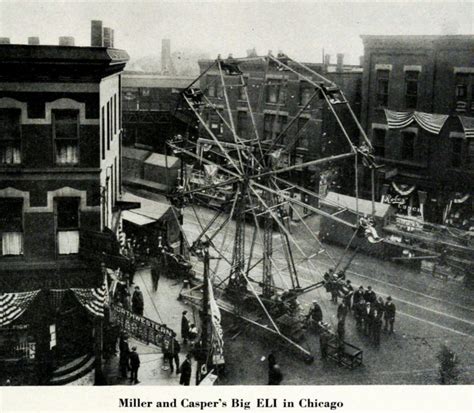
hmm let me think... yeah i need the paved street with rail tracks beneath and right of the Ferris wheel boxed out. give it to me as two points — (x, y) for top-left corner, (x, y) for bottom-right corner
(178, 203), (474, 384)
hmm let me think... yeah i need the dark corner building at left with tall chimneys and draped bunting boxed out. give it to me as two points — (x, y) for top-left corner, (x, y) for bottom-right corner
(0, 22), (128, 383)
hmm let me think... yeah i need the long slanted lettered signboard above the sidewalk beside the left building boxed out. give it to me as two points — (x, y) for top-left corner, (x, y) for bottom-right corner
(110, 304), (173, 347)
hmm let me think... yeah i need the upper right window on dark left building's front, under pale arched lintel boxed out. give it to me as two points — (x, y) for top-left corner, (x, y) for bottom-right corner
(53, 110), (79, 165)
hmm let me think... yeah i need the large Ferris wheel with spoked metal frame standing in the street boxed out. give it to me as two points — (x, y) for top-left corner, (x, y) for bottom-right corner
(168, 54), (377, 358)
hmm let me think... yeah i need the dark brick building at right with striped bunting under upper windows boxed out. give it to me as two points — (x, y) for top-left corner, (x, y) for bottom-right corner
(361, 36), (474, 225)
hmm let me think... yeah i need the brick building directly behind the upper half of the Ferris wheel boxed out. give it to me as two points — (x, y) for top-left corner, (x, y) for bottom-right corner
(199, 55), (362, 192)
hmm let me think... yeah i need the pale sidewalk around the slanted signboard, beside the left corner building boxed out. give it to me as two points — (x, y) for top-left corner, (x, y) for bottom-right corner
(103, 267), (198, 386)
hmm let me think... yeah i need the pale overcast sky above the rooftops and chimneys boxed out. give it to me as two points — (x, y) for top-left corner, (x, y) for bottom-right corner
(0, 0), (474, 63)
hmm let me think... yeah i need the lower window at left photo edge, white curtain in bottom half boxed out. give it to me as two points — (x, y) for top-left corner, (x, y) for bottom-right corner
(0, 198), (23, 256)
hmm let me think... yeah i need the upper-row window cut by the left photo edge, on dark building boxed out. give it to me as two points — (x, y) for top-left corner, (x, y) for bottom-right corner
(0, 109), (21, 165)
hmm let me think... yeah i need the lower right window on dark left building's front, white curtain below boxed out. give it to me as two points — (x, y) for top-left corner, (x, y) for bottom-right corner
(56, 198), (79, 255)
